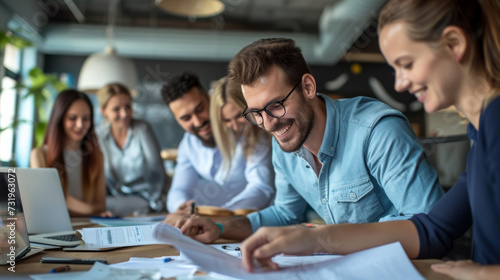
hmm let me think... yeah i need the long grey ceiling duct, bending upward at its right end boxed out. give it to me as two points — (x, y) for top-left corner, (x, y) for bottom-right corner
(17, 0), (386, 65)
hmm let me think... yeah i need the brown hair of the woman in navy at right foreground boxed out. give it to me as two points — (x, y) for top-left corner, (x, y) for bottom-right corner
(378, 0), (500, 91)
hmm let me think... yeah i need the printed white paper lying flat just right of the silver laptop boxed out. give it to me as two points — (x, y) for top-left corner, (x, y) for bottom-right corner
(80, 225), (159, 248)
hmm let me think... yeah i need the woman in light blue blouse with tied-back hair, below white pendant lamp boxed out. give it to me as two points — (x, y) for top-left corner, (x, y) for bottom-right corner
(97, 83), (166, 215)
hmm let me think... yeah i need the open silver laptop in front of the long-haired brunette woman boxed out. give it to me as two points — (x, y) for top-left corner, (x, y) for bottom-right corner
(0, 167), (82, 247)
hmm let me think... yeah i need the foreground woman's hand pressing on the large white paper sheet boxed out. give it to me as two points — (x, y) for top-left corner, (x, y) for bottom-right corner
(241, 226), (323, 272)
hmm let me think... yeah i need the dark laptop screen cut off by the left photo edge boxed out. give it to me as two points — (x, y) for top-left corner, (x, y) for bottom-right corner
(0, 168), (30, 267)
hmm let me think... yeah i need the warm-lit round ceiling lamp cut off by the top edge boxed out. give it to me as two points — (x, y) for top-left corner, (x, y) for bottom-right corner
(155, 0), (224, 18)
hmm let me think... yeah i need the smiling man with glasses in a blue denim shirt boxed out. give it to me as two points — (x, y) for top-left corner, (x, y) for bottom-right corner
(174, 39), (443, 243)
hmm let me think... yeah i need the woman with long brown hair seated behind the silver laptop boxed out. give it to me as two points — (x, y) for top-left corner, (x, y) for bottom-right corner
(30, 90), (107, 216)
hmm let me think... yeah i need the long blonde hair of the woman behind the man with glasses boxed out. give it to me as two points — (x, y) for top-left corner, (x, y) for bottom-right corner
(210, 77), (271, 174)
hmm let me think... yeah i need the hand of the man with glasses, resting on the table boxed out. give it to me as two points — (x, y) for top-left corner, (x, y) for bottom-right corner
(175, 215), (220, 243)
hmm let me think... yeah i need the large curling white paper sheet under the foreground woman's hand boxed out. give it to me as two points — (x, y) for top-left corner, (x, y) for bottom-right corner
(153, 223), (424, 280)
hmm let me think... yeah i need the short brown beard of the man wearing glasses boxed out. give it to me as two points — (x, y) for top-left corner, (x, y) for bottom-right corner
(266, 102), (314, 153)
